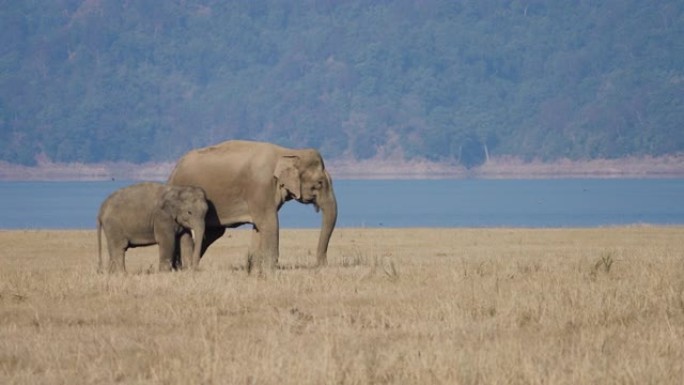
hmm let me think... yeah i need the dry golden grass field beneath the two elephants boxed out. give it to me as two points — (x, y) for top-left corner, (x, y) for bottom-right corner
(0, 226), (684, 384)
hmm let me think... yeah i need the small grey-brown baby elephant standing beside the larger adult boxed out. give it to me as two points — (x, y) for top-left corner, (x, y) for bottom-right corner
(97, 182), (208, 272)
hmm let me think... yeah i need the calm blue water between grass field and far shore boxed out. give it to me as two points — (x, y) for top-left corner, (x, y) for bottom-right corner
(0, 179), (684, 229)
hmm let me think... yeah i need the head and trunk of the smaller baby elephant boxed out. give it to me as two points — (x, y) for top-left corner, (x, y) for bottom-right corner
(160, 186), (208, 262)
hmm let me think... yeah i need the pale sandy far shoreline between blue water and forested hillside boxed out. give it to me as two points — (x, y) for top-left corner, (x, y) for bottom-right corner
(0, 154), (684, 181)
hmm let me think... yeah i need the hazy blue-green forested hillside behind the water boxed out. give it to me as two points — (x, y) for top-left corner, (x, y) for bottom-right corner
(0, 0), (684, 167)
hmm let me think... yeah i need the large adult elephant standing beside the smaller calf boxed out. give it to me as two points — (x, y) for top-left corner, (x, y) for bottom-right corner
(168, 140), (337, 272)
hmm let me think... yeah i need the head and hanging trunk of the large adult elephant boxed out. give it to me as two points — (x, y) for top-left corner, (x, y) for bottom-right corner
(274, 149), (337, 265)
